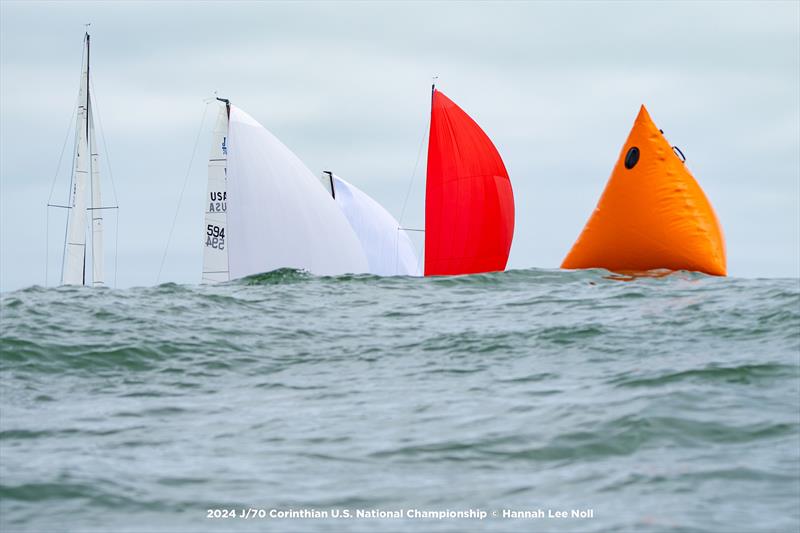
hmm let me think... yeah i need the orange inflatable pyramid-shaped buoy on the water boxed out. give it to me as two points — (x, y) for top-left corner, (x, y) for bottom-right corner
(561, 106), (727, 276)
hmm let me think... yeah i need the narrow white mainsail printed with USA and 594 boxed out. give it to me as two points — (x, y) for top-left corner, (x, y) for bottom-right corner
(203, 104), (230, 282)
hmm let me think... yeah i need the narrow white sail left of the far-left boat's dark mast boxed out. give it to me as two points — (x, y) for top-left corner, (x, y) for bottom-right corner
(61, 40), (90, 285)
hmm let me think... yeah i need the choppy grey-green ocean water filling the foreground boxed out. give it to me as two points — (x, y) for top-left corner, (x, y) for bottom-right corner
(0, 269), (800, 532)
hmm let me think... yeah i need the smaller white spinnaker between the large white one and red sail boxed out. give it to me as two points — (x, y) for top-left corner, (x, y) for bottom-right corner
(326, 173), (422, 276)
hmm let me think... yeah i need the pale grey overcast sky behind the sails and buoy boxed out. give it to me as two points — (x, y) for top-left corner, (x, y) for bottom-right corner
(0, 1), (800, 291)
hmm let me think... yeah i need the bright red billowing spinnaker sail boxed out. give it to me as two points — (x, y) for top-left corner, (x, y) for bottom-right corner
(425, 91), (514, 276)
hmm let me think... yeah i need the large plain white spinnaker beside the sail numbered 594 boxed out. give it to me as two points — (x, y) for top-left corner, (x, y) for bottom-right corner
(228, 106), (368, 279)
